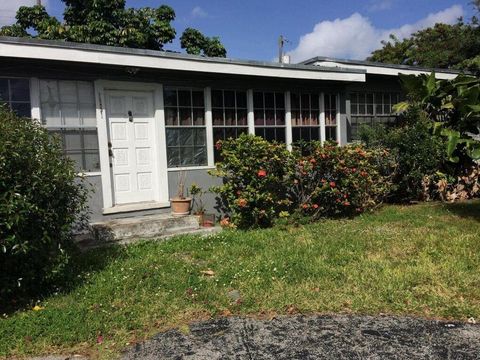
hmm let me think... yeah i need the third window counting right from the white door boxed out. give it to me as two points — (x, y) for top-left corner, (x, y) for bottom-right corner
(253, 92), (285, 142)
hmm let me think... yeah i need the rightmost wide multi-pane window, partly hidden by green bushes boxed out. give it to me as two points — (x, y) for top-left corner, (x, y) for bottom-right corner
(349, 92), (400, 141)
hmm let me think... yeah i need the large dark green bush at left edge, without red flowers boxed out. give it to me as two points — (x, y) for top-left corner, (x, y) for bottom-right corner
(0, 107), (87, 307)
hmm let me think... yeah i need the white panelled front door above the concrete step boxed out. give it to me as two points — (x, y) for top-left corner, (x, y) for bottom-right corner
(106, 91), (159, 205)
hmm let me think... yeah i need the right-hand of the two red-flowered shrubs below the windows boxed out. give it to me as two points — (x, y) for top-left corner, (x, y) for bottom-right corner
(290, 142), (395, 218)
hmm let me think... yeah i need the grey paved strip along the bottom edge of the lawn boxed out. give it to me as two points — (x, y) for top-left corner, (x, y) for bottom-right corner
(123, 316), (480, 360)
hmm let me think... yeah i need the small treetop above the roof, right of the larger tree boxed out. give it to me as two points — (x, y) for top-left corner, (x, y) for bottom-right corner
(180, 28), (227, 57)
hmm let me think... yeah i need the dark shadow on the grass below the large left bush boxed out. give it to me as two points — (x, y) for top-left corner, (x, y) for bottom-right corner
(0, 245), (127, 314)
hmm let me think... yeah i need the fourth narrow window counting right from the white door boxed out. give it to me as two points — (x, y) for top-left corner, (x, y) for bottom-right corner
(291, 93), (320, 142)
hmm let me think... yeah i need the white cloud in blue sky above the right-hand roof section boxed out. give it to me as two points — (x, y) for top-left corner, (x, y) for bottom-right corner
(289, 5), (463, 62)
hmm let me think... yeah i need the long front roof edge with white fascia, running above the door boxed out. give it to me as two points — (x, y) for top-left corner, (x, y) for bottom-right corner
(0, 36), (366, 82)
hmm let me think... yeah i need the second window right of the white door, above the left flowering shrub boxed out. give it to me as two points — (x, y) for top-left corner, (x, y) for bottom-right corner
(212, 90), (248, 161)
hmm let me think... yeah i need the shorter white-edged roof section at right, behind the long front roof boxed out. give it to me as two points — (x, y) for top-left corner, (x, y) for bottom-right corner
(300, 56), (462, 79)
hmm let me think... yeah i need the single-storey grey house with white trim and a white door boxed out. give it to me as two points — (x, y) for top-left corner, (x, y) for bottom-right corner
(0, 37), (457, 220)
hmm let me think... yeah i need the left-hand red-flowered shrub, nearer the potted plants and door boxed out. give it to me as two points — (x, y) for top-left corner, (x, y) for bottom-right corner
(211, 134), (292, 228)
